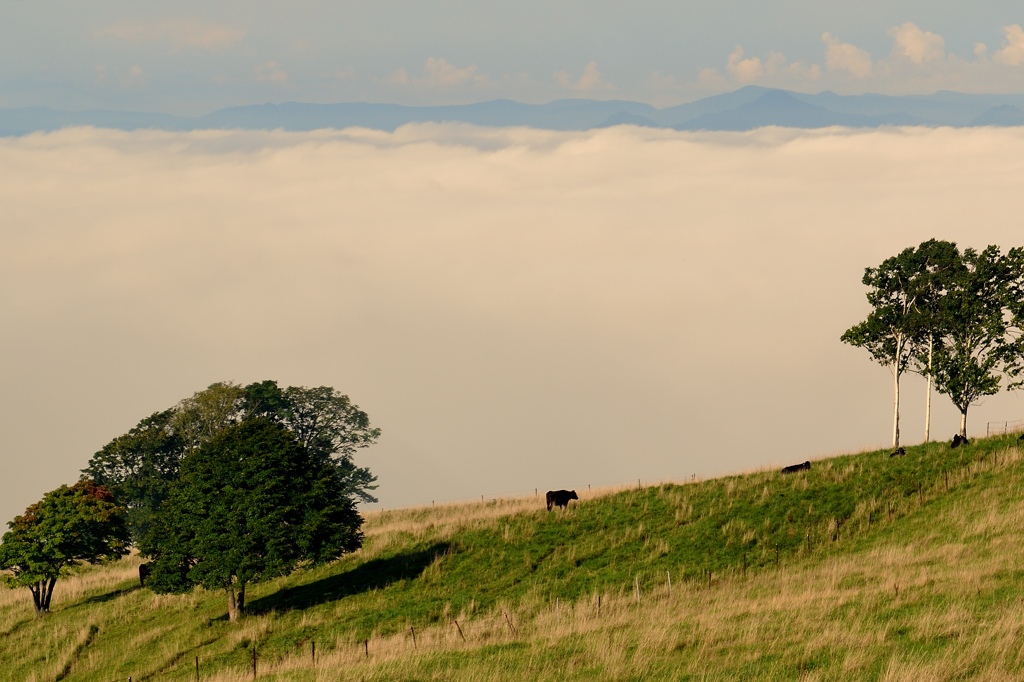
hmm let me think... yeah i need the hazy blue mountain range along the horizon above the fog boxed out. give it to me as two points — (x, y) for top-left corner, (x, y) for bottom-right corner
(0, 86), (1024, 135)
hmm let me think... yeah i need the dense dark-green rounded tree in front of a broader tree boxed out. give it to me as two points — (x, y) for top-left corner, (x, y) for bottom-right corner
(140, 414), (362, 622)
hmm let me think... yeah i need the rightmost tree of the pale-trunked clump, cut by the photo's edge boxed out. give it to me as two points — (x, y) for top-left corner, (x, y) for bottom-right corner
(932, 246), (1022, 437)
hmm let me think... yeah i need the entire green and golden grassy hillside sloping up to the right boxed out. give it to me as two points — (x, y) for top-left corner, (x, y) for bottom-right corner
(0, 438), (1024, 682)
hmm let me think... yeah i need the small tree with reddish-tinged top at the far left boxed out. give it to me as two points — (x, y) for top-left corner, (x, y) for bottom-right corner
(0, 480), (129, 616)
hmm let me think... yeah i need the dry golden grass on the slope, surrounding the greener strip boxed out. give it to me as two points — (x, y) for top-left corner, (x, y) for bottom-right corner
(0, 438), (1024, 682)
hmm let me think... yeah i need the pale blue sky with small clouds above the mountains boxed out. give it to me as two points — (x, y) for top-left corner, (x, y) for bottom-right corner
(6, 0), (1024, 115)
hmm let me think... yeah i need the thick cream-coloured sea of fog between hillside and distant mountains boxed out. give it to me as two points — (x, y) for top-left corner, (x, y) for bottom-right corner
(0, 125), (1024, 520)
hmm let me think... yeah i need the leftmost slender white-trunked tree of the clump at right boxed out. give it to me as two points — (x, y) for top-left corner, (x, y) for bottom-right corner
(841, 240), (942, 449)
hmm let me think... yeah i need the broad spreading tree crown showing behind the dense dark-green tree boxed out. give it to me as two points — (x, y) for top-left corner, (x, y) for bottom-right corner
(82, 381), (380, 544)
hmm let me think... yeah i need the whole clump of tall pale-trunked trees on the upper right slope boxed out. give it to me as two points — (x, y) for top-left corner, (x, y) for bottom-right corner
(842, 240), (1024, 447)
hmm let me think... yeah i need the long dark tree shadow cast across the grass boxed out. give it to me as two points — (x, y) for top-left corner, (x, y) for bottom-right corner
(246, 543), (453, 614)
